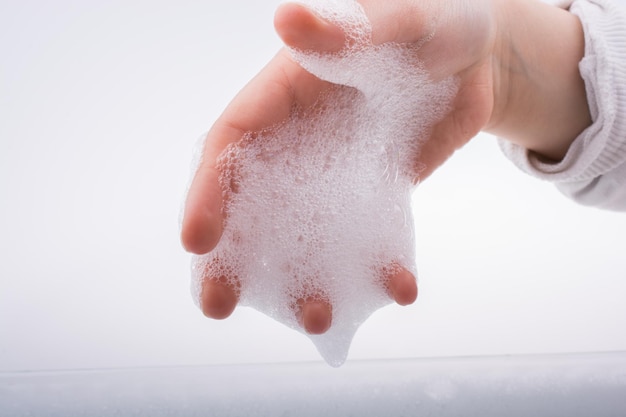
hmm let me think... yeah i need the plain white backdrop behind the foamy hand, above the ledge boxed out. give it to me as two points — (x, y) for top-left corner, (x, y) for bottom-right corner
(0, 0), (626, 371)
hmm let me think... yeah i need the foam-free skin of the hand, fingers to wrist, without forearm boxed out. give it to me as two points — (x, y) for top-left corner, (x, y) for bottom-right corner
(182, 1), (492, 334)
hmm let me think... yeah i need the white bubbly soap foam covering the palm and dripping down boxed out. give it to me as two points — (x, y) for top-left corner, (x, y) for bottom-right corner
(192, 0), (455, 366)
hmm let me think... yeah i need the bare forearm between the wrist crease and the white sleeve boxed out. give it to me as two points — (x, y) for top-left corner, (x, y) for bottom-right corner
(485, 0), (591, 161)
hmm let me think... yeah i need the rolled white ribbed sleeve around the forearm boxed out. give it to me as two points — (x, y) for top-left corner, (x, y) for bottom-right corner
(499, 0), (626, 211)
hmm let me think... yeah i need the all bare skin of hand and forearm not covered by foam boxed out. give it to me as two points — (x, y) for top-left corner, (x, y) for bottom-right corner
(181, 0), (591, 334)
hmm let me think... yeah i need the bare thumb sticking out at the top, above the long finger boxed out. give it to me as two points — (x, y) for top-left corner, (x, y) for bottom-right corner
(274, 3), (345, 52)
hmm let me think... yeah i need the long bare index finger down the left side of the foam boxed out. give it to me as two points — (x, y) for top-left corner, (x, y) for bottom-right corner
(181, 51), (329, 254)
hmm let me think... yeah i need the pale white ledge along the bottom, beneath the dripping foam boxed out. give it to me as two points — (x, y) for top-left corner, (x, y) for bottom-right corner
(0, 353), (626, 417)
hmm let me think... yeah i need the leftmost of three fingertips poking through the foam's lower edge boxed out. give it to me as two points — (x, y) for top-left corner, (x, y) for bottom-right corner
(200, 277), (239, 320)
